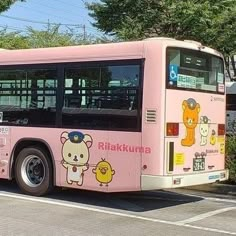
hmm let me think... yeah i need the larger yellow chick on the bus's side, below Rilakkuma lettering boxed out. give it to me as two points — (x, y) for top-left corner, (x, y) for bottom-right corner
(93, 158), (115, 186)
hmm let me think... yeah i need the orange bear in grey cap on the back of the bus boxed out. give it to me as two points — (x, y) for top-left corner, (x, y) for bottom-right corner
(181, 98), (200, 147)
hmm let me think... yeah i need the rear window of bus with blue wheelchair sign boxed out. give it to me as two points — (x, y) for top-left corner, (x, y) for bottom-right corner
(167, 48), (225, 93)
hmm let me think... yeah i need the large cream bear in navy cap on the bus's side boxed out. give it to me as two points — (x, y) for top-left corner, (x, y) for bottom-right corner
(61, 131), (93, 186)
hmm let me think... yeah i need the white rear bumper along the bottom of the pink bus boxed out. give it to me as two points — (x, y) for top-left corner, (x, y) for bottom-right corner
(141, 170), (229, 190)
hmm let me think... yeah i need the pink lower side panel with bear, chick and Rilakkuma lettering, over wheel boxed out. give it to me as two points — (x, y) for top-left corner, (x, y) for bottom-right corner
(12, 127), (143, 192)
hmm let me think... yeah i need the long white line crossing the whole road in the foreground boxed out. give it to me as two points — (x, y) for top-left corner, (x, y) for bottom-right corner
(0, 191), (236, 235)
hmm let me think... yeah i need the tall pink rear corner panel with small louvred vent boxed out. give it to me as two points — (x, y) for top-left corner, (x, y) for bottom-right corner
(142, 42), (165, 175)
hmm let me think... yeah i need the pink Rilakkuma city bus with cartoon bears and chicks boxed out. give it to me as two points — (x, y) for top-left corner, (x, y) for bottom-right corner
(0, 38), (228, 196)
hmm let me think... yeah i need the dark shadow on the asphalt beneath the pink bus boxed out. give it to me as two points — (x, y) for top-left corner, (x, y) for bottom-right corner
(0, 180), (202, 212)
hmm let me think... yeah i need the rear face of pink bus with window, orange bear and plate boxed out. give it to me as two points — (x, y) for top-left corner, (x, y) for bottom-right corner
(164, 44), (227, 187)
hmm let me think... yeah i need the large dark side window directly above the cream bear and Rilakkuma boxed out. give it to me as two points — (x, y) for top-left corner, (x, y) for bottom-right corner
(62, 61), (140, 130)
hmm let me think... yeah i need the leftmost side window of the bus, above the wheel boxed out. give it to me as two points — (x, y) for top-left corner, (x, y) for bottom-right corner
(0, 69), (57, 126)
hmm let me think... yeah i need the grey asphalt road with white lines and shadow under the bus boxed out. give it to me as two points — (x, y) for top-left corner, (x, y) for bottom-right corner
(0, 181), (236, 236)
